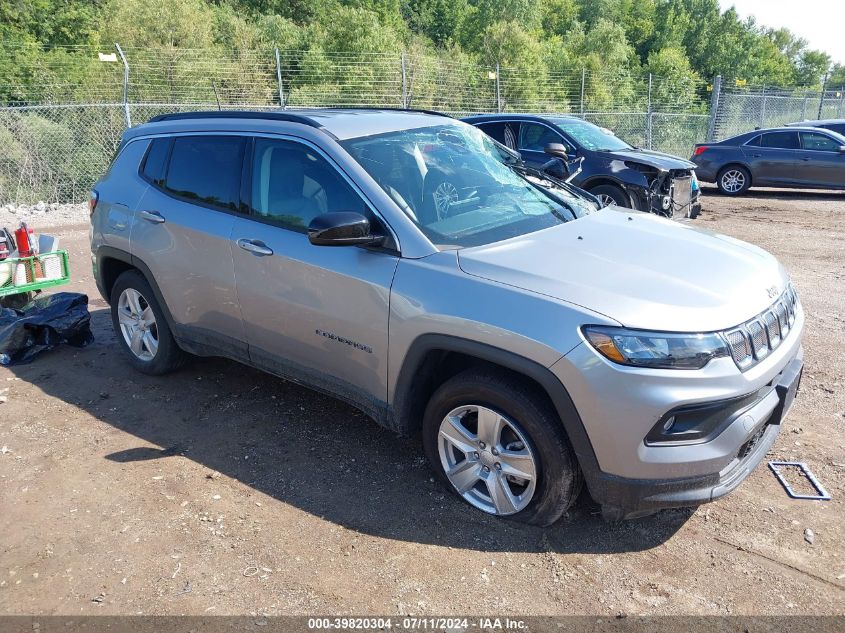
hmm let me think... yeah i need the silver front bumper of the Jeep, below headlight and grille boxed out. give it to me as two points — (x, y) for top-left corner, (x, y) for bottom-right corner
(551, 303), (804, 518)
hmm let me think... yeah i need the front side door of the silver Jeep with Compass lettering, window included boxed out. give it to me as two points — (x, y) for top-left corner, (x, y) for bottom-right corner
(231, 139), (398, 406)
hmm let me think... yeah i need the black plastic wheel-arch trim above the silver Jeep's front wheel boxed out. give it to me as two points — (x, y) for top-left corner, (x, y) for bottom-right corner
(390, 334), (601, 486)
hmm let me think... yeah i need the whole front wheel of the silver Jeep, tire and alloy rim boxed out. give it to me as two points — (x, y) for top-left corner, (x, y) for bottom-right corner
(423, 370), (581, 525)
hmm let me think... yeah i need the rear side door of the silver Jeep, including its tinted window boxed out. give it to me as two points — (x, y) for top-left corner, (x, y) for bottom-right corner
(132, 135), (247, 359)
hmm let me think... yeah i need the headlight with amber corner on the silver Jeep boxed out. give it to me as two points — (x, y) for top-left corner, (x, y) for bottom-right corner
(581, 325), (729, 369)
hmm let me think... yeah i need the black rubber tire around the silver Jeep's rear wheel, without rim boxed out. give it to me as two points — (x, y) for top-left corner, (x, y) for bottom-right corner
(111, 270), (187, 376)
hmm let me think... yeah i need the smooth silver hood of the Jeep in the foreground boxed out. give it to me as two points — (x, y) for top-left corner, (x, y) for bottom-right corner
(458, 207), (789, 332)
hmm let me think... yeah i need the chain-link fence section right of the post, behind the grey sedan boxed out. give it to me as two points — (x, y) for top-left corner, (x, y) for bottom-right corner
(711, 80), (845, 140)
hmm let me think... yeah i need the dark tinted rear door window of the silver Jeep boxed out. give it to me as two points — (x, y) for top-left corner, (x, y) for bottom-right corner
(164, 136), (245, 211)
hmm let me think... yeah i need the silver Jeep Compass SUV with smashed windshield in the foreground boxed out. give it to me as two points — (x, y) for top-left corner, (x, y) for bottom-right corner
(91, 110), (804, 524)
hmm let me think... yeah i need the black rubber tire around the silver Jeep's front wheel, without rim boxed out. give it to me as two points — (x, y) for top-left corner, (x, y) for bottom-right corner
(422, 369), (583, 525)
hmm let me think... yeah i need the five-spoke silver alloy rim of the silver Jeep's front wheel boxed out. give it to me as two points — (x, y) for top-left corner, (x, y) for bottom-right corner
(437, 405), (538, 516)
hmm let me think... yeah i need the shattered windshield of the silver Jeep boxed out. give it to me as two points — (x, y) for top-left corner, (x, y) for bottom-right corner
(342, 123), (596, 248)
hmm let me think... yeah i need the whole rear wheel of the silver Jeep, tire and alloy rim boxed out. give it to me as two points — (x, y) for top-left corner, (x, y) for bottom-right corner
(111, 270), (186, 375)
